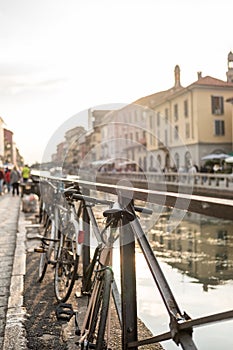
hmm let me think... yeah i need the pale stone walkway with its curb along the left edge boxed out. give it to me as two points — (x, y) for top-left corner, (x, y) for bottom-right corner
(0, 193), (26, 350)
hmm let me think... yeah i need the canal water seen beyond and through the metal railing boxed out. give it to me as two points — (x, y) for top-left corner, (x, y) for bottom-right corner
(89, 193), (233, 350)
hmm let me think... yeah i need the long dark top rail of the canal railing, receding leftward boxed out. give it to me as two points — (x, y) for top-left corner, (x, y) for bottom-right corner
(35, 173), (233, 220)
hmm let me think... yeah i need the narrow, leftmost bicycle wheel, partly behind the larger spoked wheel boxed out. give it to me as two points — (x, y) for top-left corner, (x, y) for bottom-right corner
(38, 217), (55, 282)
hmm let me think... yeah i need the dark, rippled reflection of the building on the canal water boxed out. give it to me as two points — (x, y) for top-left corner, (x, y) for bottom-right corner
(148, 209), (233, 291)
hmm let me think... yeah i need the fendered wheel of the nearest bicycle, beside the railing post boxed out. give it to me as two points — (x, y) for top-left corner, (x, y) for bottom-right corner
(80, 267), (113, 350)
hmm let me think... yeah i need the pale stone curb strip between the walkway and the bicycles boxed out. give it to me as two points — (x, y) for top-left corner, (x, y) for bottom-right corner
(3, 203), (27, 350)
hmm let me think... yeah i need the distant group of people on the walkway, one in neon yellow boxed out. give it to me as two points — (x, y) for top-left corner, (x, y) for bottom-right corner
(0, 164), (30, 196)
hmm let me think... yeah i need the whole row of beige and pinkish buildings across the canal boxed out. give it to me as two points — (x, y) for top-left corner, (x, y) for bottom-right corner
(51, 52), (233, 172)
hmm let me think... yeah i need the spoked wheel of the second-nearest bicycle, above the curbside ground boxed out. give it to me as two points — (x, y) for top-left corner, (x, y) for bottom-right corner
(54, 223), (79, 302)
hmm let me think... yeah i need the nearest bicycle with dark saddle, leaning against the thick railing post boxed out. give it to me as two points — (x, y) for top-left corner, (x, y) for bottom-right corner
(69, 195), (148, 350)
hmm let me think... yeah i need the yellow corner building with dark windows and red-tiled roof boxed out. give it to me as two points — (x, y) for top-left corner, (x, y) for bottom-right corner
(135, 53), (233, 169)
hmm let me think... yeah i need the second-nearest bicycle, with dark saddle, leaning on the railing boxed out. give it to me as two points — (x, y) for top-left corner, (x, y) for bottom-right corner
(54, 185), (114, 303)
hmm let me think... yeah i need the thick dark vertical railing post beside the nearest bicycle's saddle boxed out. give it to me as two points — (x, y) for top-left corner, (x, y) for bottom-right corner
(120, 198), (138, 350)
